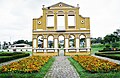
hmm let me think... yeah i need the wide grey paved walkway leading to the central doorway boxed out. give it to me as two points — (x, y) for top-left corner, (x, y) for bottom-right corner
(44, 56), (80, 78)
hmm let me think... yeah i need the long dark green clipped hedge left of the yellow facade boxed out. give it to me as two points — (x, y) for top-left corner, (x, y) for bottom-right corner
(0, 53), (30, 63)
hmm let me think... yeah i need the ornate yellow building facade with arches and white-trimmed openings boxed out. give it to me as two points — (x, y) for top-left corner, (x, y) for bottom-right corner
(32, 2), (91, 55)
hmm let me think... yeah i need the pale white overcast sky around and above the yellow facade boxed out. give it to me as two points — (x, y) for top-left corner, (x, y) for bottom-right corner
(0, 0), (120, 42)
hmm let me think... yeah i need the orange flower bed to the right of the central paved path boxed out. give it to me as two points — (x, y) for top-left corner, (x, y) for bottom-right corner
(73, 56), (120, 73)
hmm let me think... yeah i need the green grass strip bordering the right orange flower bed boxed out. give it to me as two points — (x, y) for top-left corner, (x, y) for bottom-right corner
(69, 58), (120, 78)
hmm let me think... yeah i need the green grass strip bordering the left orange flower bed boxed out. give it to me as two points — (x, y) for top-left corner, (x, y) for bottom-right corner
(0, 58), (55, 78)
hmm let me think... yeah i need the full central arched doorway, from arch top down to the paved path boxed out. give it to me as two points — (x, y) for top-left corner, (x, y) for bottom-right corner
(58, 35), (65, 56)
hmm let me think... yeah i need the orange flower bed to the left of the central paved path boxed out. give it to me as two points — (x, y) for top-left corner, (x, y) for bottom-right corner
(0, 56), (51, 73)
